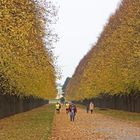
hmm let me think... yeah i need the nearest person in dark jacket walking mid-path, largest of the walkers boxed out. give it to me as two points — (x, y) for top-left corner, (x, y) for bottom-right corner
(69, 103), (77, 122)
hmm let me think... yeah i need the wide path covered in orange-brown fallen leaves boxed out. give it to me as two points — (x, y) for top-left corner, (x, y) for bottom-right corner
(49, 107), (140, 140)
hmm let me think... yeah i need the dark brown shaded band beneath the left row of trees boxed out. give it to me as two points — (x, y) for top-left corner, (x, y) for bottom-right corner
(0, 94), (48, 118)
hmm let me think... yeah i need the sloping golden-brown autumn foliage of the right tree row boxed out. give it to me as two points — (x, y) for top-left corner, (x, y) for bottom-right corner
(67, 0), (140, 100)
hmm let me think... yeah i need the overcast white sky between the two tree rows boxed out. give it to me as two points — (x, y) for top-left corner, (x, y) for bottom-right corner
(53, 0), (121, 84)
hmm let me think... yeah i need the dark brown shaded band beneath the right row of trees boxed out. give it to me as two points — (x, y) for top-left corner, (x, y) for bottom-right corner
(82, 94), (140, 112)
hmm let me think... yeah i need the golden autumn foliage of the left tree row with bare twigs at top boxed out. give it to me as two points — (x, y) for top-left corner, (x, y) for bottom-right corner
(0, 0), (56, 98)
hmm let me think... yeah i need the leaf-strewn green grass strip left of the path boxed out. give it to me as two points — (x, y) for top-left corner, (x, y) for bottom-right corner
(0, 105), (55, 140)
